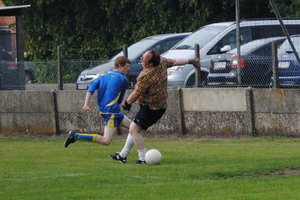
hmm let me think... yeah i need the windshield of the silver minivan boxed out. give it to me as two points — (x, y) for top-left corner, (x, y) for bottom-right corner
(172, 26), (227, 49)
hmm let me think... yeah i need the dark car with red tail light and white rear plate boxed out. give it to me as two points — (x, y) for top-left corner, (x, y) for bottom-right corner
(207, 37), (285, 87)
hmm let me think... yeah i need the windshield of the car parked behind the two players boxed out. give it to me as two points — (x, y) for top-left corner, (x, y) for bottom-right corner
(112, 39), (157, 60)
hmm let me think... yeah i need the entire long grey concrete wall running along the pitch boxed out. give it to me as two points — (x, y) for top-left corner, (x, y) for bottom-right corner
(0, 88), (300, 137)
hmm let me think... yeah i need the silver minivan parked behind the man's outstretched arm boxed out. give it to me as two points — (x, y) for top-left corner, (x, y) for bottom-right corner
(163, 19), (300, 88)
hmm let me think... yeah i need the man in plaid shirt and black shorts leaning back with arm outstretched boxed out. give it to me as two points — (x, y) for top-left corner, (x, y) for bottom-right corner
(109, 50), (199, 164)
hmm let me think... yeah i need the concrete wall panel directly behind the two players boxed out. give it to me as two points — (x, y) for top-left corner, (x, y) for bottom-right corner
(56, 90), (181, 137)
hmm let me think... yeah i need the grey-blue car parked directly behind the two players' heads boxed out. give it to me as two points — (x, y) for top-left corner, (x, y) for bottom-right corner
(76, 32), (191, 90)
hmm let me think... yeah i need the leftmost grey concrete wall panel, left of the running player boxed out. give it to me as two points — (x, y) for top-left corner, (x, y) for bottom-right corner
(0, 91), (56, 133)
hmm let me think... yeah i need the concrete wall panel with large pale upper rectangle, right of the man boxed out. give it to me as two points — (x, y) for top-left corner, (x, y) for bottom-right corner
(182, 88), (252, 137)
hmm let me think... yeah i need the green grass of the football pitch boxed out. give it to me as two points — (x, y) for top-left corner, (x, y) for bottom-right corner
(0, 137), (300, 200)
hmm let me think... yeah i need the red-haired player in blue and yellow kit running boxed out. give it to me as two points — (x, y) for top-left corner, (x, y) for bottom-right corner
(64, 56), (131, 147)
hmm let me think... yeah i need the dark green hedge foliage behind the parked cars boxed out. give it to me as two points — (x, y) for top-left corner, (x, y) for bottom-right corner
(3, 0), (294, 61)
